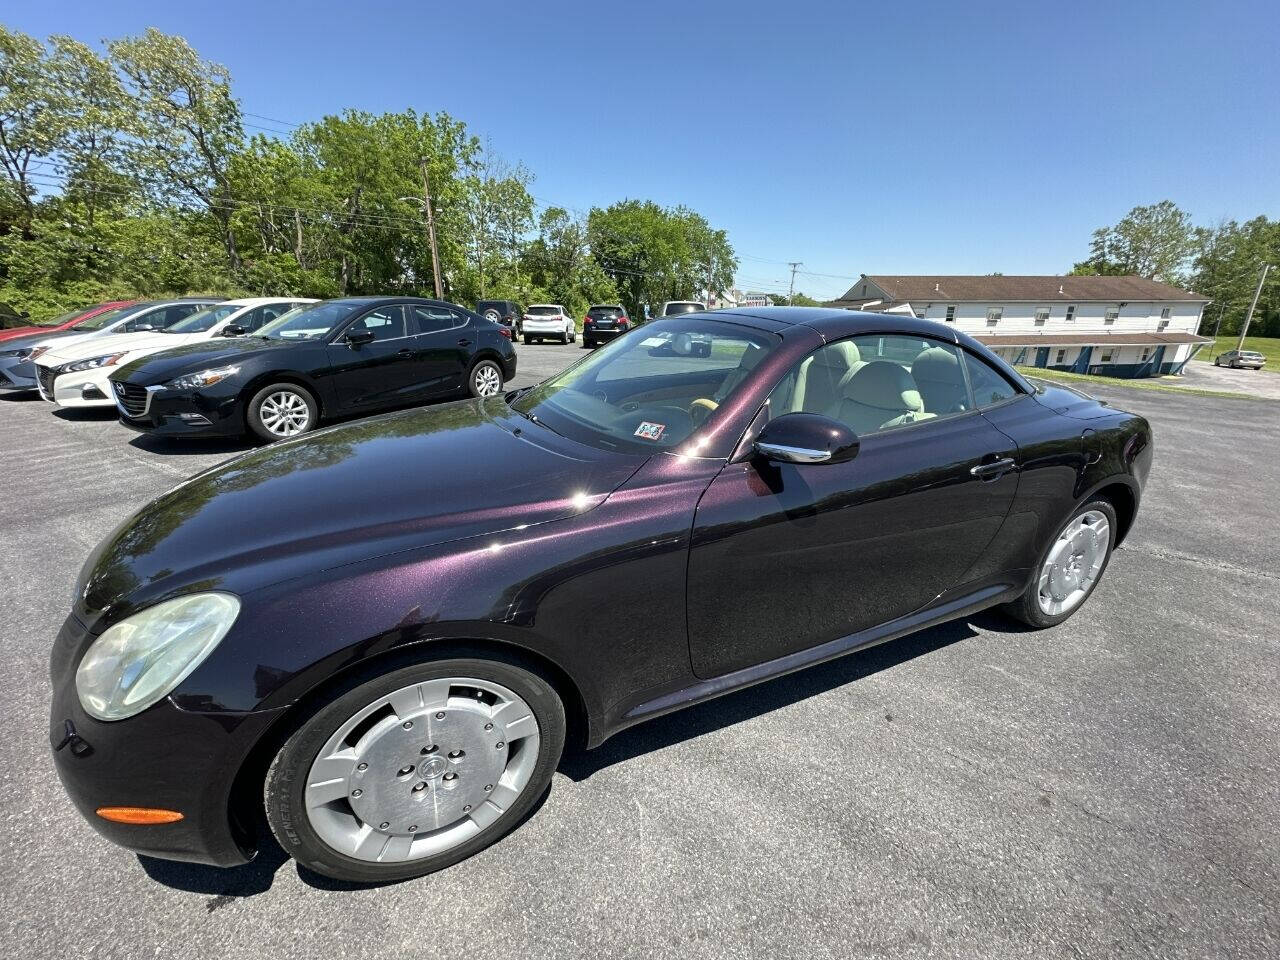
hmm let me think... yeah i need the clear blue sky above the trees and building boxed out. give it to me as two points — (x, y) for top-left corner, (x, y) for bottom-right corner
(12, 0), (1280, 297)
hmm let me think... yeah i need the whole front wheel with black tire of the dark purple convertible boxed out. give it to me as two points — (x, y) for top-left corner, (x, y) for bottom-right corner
(262, 657), (566, 883)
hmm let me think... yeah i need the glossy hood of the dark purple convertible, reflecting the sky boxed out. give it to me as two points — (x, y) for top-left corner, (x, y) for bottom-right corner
(76, 397), (644, 628)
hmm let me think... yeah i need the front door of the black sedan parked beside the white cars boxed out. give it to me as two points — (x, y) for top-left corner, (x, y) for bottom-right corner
(326, 303), (417, 410)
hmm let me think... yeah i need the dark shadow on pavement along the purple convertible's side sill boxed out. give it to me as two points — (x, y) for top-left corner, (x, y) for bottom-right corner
(559, 611), (1021, 781)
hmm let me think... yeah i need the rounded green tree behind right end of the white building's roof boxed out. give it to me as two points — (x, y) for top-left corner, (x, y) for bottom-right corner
(1071, 200), (1196, 284)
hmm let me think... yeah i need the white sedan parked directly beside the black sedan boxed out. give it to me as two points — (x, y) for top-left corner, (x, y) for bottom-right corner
(36, 297), (315, 407)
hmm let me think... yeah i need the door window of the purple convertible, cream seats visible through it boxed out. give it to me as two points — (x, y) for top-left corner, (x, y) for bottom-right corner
(769, 334), (972, 435)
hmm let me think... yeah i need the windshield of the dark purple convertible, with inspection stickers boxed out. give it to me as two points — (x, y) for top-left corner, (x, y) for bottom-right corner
(511, 317), (780, 453)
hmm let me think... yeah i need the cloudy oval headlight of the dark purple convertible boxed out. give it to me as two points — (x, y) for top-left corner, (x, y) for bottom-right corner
(76, 593), (239, 721)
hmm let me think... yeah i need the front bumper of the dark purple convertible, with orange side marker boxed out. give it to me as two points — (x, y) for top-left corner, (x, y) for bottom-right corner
(49, 617), (287, 867)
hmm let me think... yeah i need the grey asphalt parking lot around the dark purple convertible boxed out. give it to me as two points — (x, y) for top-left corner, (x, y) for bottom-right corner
(0, 346), (1280, 960)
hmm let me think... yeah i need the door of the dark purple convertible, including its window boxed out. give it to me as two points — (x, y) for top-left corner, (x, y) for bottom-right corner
(687, 337), (1018, 678)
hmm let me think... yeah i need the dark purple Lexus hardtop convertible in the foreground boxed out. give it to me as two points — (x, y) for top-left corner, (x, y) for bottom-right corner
(50, 308), (1152, 881)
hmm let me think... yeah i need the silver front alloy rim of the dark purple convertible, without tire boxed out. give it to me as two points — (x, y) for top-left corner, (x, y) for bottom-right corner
(305, 677), (540, 863)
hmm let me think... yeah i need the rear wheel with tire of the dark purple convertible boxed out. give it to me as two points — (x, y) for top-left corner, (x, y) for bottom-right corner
(1004, 499), (1119, 628)
